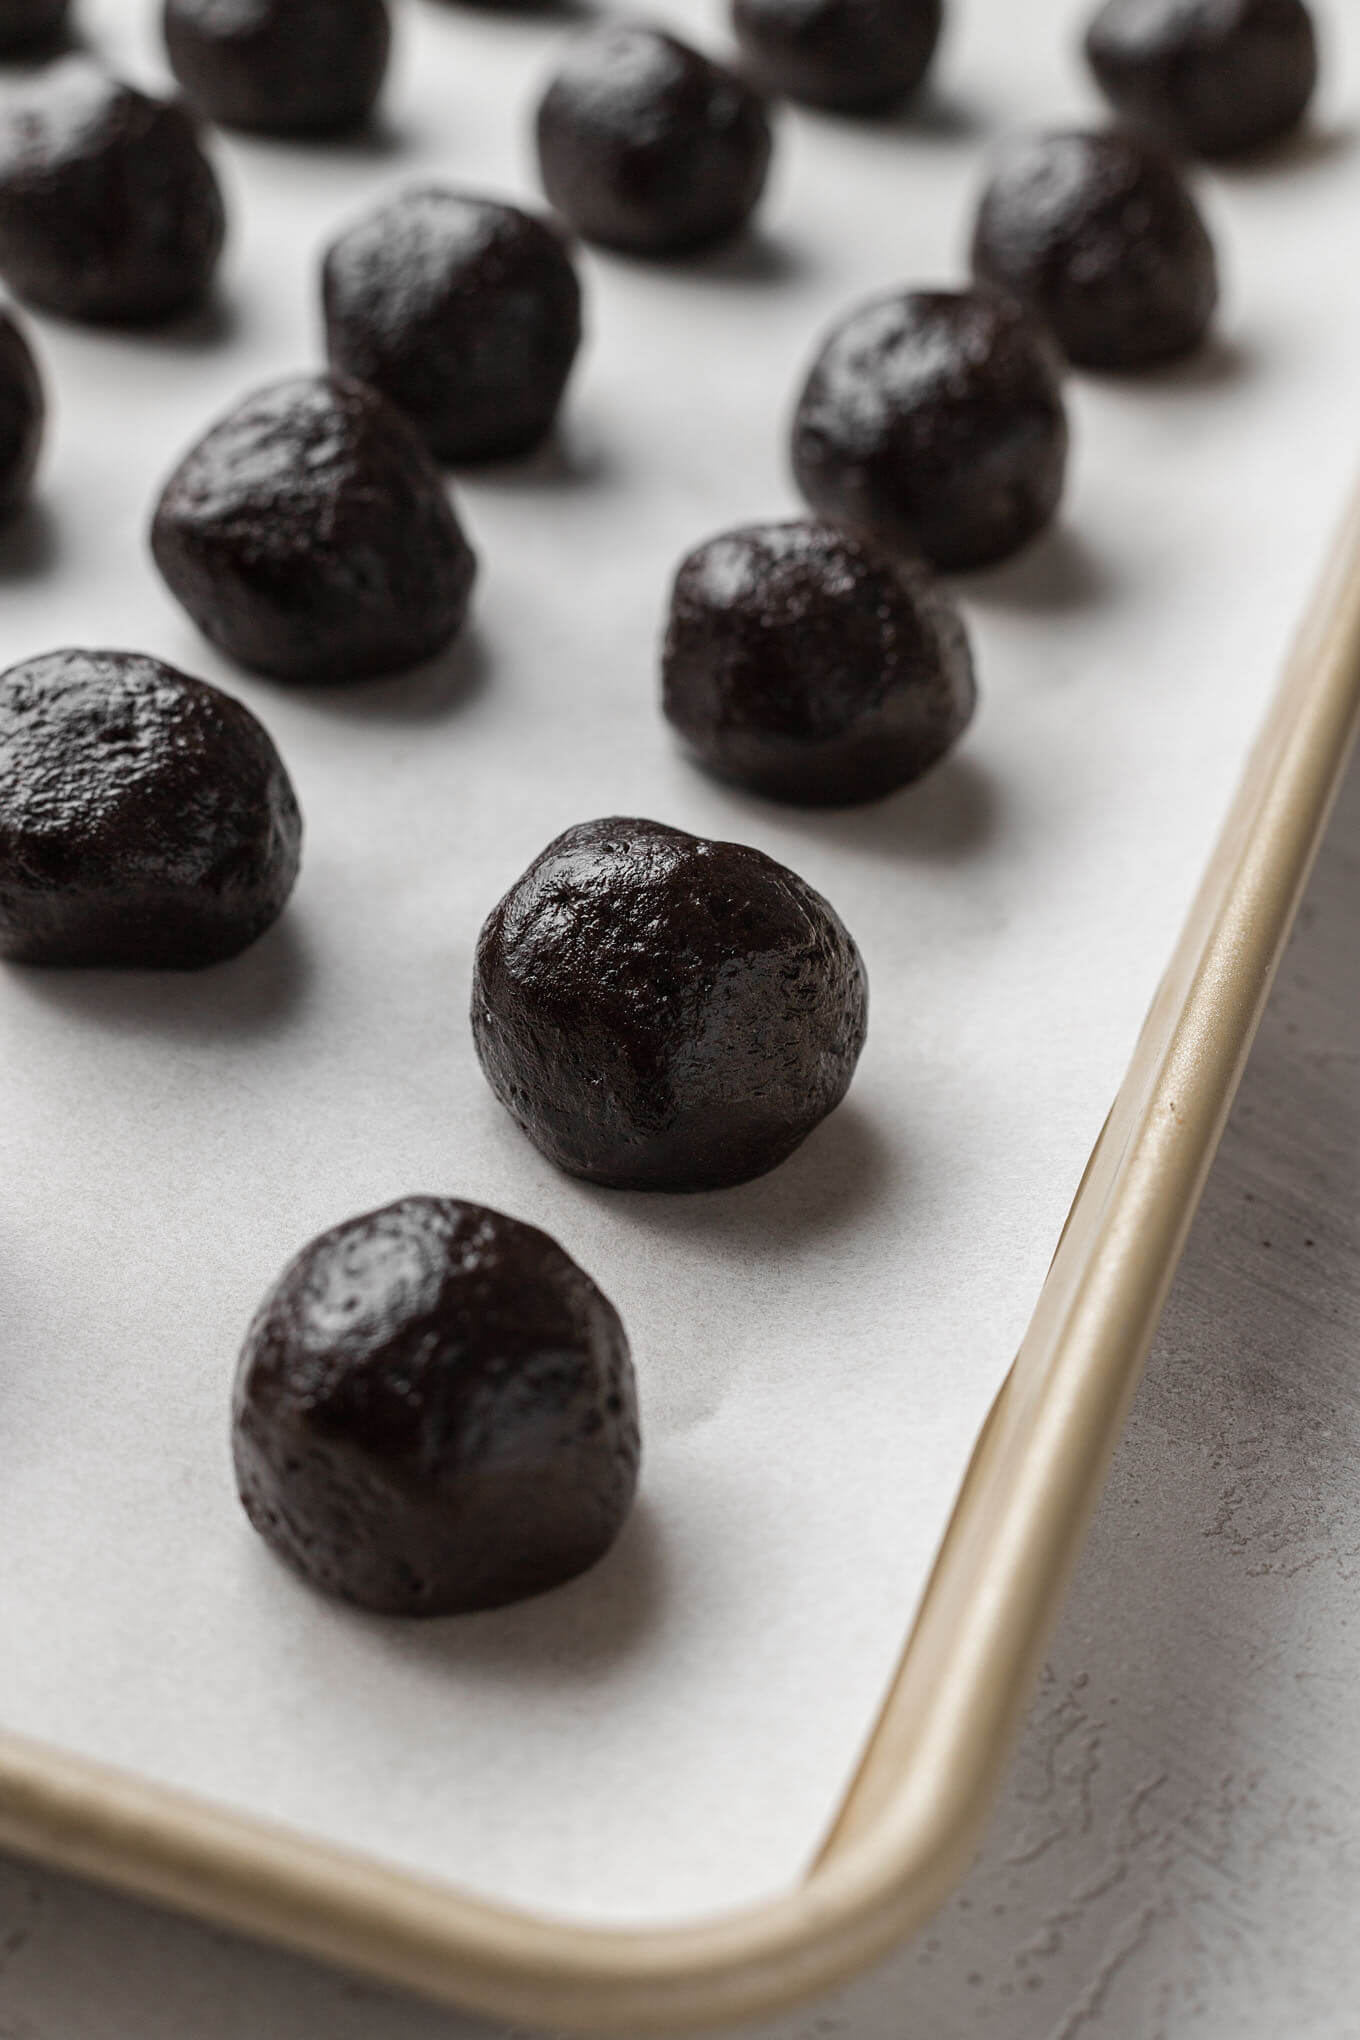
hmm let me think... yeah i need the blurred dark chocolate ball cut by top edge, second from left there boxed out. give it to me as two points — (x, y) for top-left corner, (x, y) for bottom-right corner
(165, 0), (391, 135)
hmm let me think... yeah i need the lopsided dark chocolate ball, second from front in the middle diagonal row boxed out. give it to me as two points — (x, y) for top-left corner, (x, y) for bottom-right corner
(151, 375), (477, 685)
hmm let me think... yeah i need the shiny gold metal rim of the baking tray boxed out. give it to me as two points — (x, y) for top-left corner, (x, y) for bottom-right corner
(0, 485), (1360, 2032)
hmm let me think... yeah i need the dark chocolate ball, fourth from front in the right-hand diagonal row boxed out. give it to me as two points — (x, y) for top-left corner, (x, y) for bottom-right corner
(793, 290), (1066, 569)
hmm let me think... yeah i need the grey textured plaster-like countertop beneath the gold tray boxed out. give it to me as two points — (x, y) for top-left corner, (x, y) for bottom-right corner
(0, 730), (1360, 2040)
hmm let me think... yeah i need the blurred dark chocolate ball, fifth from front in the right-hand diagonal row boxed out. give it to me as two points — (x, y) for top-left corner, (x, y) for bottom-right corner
(973, 135), (1219, 369)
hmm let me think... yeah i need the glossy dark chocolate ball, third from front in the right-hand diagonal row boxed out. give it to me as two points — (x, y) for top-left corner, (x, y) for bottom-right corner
(663, 520), (977, 808)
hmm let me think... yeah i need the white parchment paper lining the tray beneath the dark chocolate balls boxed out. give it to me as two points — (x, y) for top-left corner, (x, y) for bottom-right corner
(0, 0), (1360, 1920)
